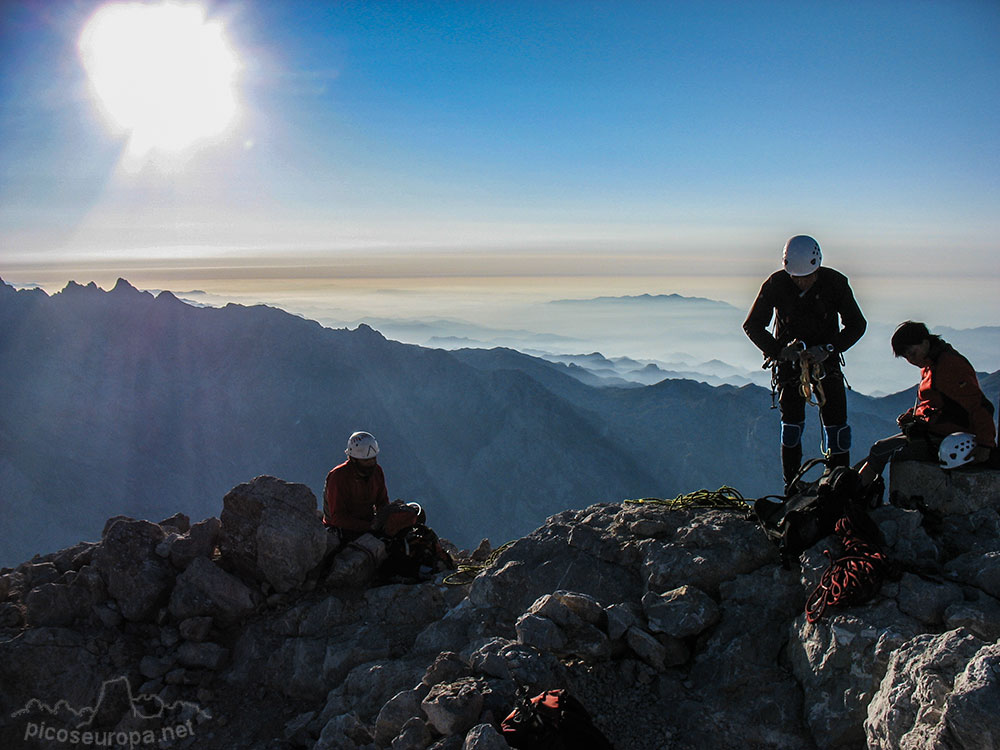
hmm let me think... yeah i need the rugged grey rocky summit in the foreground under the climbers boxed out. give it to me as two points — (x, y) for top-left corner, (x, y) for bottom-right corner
(0, 463), (1000, 750)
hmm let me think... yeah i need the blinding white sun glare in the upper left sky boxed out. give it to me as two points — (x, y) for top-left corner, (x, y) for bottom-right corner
(79, 3), (239, 154)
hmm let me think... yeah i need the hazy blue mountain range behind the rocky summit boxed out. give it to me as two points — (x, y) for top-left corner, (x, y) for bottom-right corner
(0, 280), (997, 565)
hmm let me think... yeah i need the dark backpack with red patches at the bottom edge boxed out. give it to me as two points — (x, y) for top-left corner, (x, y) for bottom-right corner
(500, 688), (614, 750)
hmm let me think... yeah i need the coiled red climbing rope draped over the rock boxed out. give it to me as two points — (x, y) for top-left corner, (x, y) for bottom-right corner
(805, 515), (889, 623)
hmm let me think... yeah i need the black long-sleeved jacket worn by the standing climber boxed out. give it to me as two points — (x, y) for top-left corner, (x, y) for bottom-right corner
(743, 266), (868, 359)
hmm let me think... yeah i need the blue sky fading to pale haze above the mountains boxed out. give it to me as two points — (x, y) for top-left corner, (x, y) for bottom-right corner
(0, 0), (1000, 326)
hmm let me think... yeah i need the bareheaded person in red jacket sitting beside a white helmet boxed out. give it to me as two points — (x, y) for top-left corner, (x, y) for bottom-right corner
(861, 320), (996, 485)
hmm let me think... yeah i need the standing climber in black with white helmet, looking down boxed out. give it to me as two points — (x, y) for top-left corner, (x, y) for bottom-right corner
(743, 234), (868, 493)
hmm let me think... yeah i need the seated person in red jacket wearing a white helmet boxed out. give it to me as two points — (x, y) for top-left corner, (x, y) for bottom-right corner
(323, 432), (389, 542)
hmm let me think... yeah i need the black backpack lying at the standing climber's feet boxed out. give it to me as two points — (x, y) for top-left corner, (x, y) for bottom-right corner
(754, 458), (882, 568)
